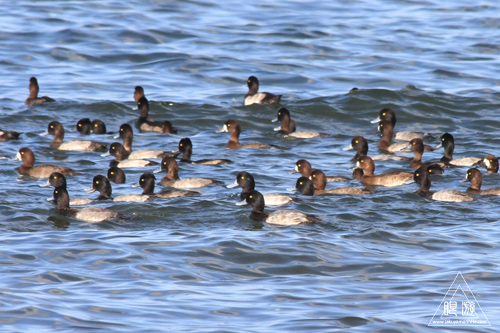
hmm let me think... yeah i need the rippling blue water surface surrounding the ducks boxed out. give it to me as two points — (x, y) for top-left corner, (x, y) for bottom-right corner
(0, 1), (500, 332)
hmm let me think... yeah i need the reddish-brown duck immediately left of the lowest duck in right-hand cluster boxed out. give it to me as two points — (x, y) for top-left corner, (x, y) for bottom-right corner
(356, 156), (413, 187)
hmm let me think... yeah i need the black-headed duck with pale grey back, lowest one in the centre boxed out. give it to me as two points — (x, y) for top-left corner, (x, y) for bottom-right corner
(238, 191), (322, 226)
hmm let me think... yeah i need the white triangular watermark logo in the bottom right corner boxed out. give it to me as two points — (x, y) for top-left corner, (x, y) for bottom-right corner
(428, 272), (491, 326)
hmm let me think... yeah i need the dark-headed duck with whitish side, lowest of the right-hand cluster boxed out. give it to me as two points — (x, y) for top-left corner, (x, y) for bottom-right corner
(413, 167), (477, 202)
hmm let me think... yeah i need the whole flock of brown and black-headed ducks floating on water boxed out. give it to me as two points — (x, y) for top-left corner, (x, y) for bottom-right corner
(4, 76), (500, 225)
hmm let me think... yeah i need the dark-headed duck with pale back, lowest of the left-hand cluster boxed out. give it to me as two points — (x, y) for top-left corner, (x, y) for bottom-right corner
(53, 187), (120, 223)
